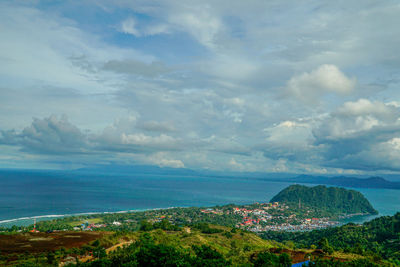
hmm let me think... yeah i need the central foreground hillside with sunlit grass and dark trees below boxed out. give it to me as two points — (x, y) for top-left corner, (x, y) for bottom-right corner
(65, 224), (394, 267)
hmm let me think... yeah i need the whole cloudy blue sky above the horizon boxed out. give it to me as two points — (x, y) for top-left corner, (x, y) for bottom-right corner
(0, 0), (400, 174)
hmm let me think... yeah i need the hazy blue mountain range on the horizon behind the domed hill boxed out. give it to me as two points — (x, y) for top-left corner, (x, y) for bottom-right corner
(287, 175), (400, 189)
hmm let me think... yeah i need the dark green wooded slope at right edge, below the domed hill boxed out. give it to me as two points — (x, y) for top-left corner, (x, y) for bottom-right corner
(261, 213), (400, 266)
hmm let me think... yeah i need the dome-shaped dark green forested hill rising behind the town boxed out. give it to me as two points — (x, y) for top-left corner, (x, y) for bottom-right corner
(271, 185), (378, 217)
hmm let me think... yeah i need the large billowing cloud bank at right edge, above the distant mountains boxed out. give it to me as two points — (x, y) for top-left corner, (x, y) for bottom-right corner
(313, 99), (400, 171)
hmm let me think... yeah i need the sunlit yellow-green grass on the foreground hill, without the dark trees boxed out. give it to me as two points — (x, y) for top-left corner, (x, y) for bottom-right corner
(96, 226), (363, 264)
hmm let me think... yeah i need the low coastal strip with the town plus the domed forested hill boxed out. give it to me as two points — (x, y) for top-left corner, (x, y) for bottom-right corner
(0, 185), (376, 233)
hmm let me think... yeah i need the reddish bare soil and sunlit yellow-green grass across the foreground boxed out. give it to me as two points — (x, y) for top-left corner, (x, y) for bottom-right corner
(0, 225), (370, 265)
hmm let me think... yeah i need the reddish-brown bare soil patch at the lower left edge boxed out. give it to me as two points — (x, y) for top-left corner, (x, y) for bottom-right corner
(0, 232), (106, 254)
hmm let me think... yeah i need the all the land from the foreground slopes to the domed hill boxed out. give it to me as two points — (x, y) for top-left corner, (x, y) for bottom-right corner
(0, 186), (400, 267)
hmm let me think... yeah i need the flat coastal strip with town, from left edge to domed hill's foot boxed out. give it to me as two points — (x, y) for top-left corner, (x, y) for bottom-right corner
(0, 202), (346, 236)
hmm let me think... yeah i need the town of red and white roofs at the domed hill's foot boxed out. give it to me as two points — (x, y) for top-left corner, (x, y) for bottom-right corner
(73, 202), (340, 233)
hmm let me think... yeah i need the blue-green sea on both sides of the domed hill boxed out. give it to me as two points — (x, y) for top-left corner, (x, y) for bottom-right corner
(0, 169), (400, 227)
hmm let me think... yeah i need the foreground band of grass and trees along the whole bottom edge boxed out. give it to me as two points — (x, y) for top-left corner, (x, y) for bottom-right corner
(0, 220), (398, 266)
